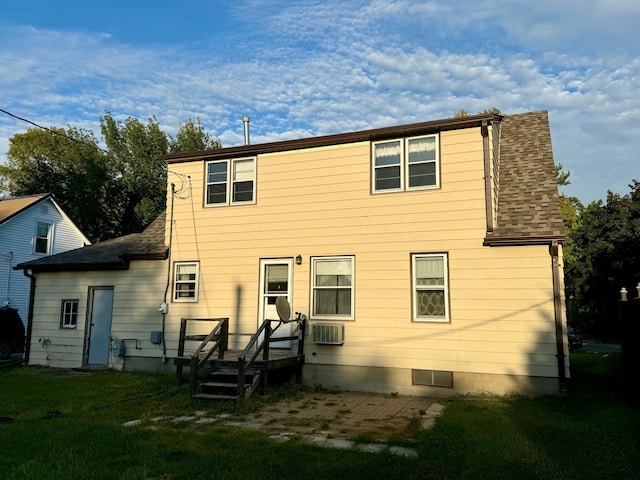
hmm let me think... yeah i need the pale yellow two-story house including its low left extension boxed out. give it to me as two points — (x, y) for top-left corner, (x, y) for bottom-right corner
(16, 111), (569, 396)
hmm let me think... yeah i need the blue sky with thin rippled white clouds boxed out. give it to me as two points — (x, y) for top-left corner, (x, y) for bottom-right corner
(0, 0), (640, 204)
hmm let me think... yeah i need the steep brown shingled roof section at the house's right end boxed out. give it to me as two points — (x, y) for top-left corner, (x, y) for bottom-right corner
(486, 110), (565, 244)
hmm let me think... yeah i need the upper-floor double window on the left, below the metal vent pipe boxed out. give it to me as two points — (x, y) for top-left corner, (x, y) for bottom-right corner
(205, 158), (256, 205)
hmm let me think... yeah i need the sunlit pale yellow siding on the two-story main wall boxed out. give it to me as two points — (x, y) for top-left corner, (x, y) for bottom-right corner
(167, 128), (557, 377)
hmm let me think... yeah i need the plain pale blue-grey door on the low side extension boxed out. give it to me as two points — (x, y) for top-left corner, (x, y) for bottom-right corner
(87, 287), (113, 365)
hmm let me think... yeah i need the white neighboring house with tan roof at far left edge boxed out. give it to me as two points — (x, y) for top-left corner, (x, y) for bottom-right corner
(0, 193), (91, 326)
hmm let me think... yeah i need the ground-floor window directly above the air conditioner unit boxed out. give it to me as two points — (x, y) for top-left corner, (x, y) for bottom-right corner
(311, 257), (354, 320)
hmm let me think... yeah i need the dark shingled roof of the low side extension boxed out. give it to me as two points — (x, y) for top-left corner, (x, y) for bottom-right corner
(14, 212), (168, 272)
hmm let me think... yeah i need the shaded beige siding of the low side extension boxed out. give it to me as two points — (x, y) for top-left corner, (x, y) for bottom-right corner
(29, 261), (166, 368)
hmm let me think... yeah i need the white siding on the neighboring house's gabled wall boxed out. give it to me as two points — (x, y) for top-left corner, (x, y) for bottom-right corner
(0, 198), (89, 324)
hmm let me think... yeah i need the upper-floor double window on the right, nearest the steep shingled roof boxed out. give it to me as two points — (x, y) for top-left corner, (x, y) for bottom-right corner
(371, 135), (440, 193)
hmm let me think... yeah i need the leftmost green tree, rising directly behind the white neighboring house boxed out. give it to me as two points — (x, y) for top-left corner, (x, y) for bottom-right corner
(0, 127), (112, 240)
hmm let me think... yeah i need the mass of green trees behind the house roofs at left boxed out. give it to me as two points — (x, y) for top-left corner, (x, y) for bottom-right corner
(0, 112), (220, 242)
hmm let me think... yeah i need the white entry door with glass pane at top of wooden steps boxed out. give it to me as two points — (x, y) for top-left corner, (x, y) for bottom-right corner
(258, 258), (293, 348)
